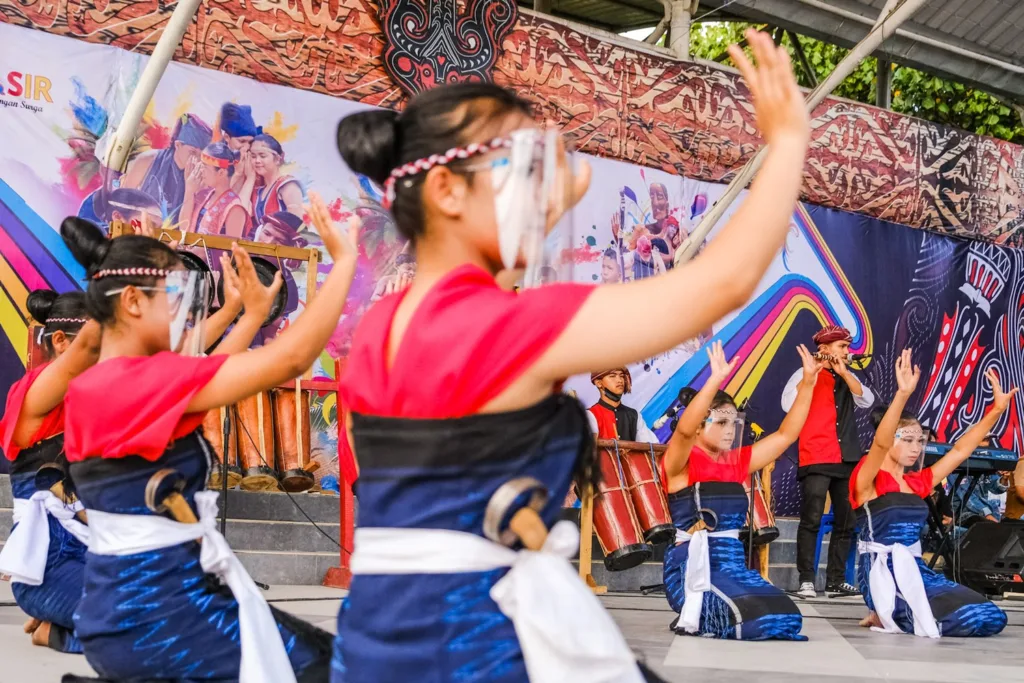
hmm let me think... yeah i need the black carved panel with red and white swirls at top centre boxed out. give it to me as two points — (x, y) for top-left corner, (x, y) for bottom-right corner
(378, 0), (519, 95)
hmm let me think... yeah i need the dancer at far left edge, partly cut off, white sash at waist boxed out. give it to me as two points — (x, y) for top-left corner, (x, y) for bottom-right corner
(0, 290), (99, 652)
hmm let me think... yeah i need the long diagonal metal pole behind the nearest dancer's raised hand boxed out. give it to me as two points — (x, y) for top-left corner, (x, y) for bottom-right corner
(676, 0), (927, 265)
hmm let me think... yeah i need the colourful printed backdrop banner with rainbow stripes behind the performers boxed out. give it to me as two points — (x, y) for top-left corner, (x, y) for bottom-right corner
(0, 25), (1024, 514)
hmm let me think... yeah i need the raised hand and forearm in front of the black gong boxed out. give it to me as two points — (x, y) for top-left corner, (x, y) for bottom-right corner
(207, 250), (284, 355)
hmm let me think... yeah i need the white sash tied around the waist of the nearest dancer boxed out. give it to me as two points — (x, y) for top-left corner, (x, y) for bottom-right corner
(352, 521), (644, 683)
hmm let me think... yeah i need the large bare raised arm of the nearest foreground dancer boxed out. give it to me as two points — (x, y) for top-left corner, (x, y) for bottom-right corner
(530, 30), (809, 381)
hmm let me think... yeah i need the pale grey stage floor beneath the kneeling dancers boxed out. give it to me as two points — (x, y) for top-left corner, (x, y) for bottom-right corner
(0, 582), (1024, 683)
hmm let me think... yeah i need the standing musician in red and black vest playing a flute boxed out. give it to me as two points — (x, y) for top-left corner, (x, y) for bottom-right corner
(782, 325), (874, 597)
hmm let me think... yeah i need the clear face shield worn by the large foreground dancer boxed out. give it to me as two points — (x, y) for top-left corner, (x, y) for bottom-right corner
(489, 128), (577, 287)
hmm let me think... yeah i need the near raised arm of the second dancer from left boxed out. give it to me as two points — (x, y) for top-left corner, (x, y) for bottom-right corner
(188, 194), (358, 413)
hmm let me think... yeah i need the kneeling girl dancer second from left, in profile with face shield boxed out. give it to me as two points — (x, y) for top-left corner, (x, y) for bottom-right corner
(61, 200), (355, 683)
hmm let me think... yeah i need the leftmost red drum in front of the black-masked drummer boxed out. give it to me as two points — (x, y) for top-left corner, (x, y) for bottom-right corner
(594, 447), (654, 571)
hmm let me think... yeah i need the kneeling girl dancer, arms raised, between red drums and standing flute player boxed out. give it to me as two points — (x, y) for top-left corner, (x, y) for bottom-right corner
(662, 342), (821, 640)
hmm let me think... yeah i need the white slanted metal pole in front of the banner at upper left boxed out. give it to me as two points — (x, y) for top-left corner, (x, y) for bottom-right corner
(103, 0), (202, 171)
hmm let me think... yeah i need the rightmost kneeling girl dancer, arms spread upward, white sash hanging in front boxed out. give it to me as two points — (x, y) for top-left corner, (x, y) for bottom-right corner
(850, 349), (1017, 638)
